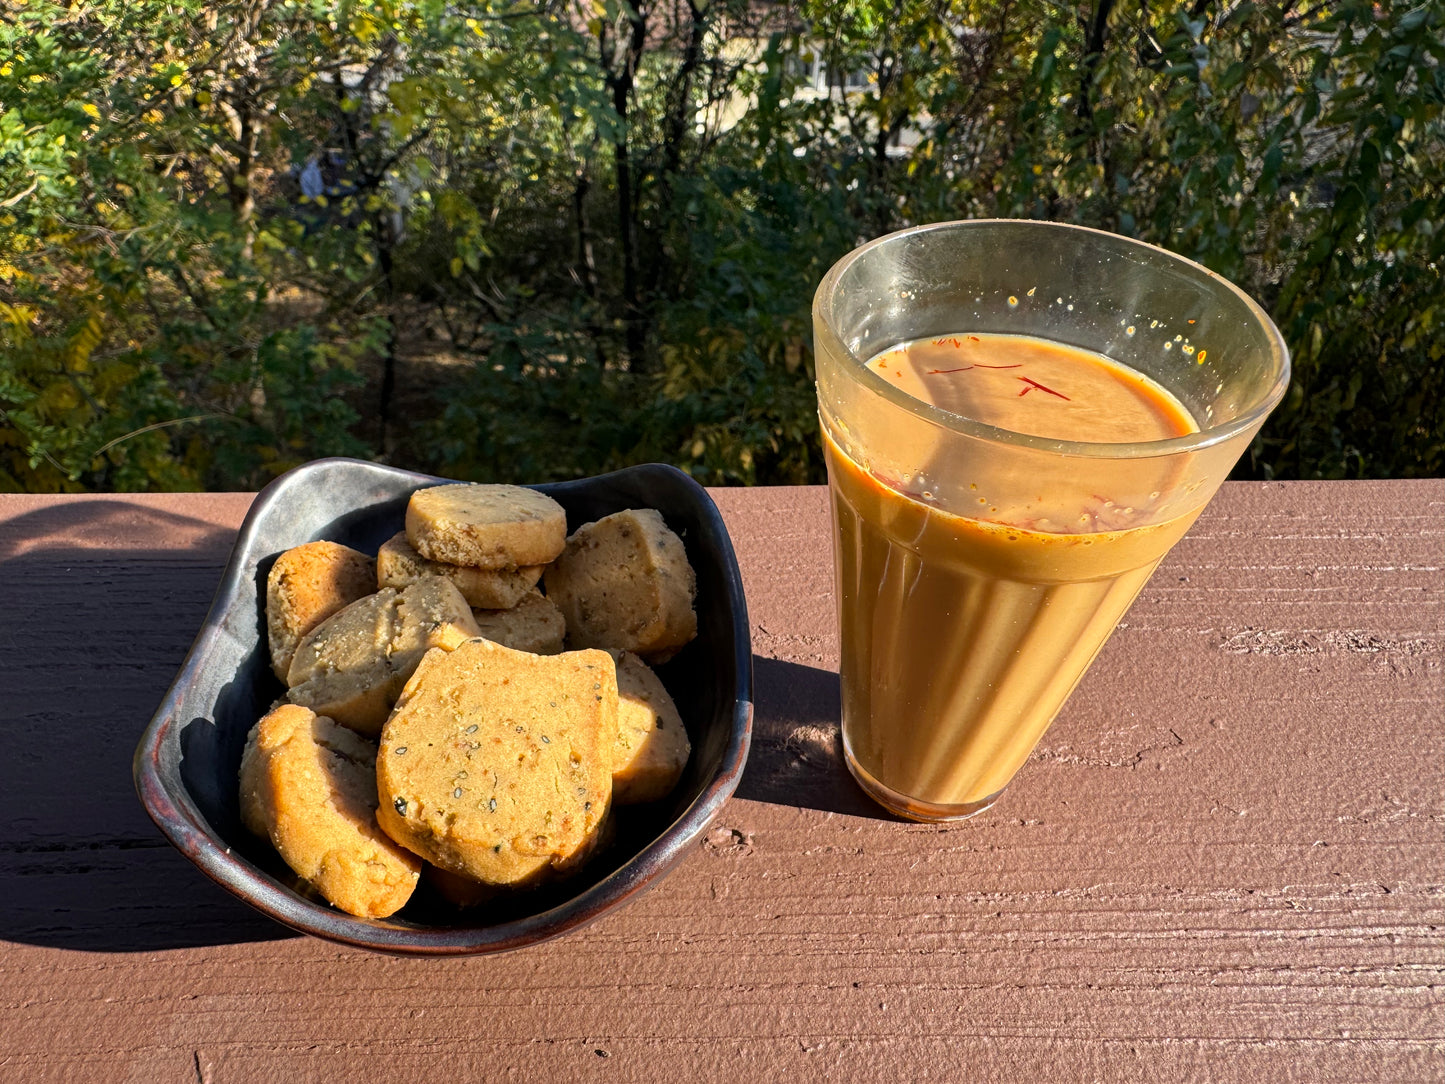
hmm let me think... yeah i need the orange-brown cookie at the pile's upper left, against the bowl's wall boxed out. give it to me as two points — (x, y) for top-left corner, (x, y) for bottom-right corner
(266, 542), (376, 681)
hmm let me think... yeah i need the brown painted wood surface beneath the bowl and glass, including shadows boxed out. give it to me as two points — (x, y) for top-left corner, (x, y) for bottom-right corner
(0, 481), (1445, 1084)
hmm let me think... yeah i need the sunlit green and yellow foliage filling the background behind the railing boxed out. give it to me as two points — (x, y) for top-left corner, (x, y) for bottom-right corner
(0, 0), (1445, 490)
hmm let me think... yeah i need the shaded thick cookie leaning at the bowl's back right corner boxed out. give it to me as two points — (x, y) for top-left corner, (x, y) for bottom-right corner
(543, 509), (698, 661)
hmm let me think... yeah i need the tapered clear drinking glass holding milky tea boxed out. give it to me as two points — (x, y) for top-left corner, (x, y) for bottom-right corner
(814, 221), (1289, 821)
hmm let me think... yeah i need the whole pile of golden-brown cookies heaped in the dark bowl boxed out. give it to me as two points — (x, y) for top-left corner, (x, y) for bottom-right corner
(240, 486), (696, 918)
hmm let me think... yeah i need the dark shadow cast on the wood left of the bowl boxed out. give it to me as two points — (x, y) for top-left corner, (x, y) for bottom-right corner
(0, 496), (293, 952)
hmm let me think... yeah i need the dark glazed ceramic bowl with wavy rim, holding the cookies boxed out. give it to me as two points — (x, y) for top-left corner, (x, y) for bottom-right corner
(134, 460), (753, 955)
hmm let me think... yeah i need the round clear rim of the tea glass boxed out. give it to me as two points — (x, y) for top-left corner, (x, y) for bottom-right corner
(812, 218), (1290, 460)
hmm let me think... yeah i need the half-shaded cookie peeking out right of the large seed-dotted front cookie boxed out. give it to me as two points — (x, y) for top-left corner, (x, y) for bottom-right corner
(608, 650), (692, 805)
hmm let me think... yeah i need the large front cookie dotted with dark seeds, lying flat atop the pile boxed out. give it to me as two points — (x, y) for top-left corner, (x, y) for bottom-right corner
(377, 639), (617, 885)
